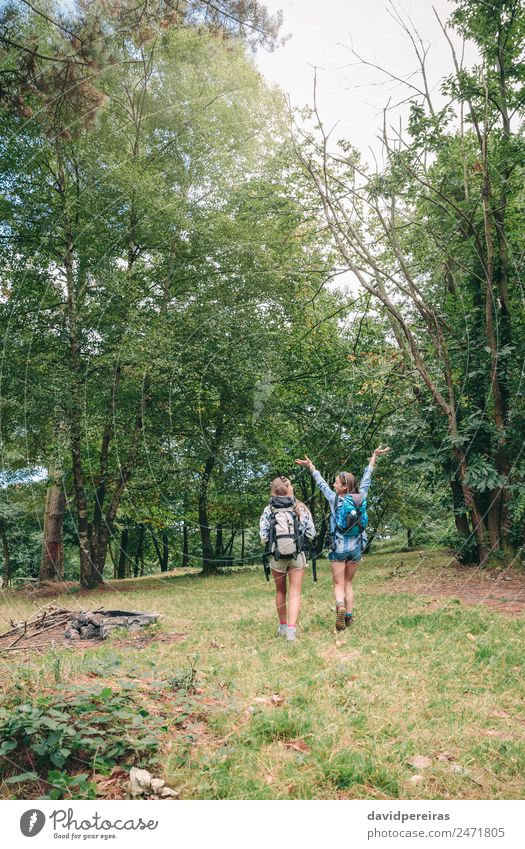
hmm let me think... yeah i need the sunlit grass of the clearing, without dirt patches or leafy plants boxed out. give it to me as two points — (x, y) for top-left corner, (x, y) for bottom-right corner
(0, 551), (525, 799)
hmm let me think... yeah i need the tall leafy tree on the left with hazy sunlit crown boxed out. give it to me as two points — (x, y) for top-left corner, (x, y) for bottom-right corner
(3, 3), (332, 587)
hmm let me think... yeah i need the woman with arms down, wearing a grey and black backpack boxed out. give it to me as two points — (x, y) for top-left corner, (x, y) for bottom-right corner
(259, 477), (315, 642)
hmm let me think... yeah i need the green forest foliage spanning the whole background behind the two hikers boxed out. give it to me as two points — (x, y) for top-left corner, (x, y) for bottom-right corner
(0, 0), (525, 579)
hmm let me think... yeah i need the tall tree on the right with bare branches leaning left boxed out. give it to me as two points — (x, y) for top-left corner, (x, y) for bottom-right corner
(297, 2), (524, 563)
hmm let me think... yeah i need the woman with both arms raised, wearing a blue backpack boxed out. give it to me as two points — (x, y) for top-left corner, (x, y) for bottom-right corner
(295, 446), (390, 631)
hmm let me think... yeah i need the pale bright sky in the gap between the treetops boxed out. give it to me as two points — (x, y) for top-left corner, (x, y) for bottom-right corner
(257, 0), (474, 158)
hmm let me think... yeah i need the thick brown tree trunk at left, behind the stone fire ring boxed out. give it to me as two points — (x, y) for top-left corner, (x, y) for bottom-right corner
(38, 467), (66, 581)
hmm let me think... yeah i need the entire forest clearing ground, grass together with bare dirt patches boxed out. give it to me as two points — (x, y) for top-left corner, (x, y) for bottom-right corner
(0, 551), (525, 799)
